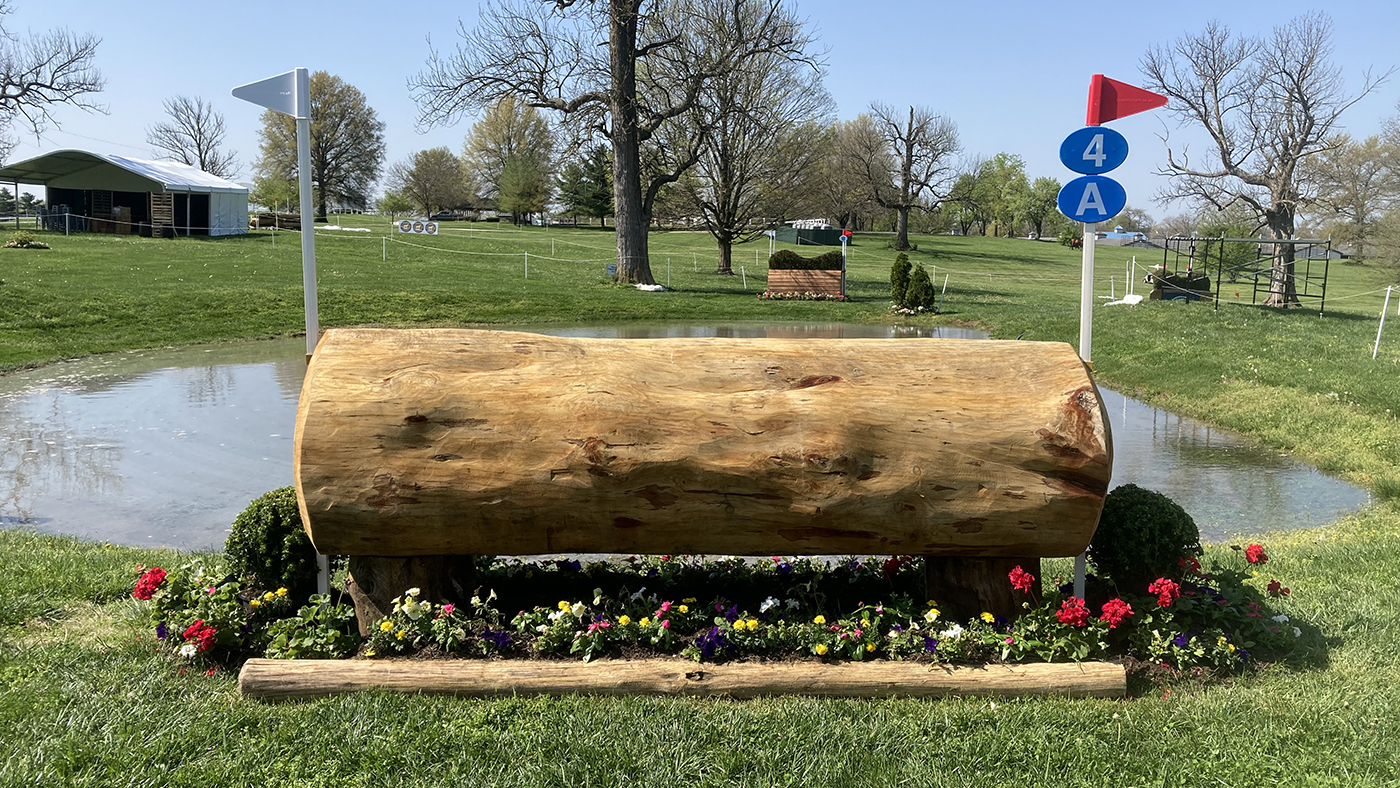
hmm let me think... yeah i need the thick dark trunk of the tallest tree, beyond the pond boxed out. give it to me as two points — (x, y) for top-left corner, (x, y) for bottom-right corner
(608, 0), (657, 284)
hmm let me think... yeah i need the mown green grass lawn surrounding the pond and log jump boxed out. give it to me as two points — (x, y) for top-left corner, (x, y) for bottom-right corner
(0, 220), (1400, 787)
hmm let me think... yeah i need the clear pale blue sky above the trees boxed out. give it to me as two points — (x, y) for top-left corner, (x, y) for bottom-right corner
(7, 0), (1400, 217)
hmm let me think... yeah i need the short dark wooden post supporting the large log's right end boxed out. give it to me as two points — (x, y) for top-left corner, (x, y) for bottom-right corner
(924, 556), (1040, 621)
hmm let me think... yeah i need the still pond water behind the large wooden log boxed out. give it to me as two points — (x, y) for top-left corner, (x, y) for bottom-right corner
(0, 323), (1368, 549)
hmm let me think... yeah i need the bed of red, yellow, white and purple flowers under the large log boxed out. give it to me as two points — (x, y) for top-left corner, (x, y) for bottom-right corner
(133, 544), (1302, 685)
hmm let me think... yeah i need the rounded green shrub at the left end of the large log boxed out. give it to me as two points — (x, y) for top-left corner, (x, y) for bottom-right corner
(224, 487), (316, 599)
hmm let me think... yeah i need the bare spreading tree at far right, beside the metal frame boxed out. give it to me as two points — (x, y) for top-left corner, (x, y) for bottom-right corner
(1142, 13), (1392, 307)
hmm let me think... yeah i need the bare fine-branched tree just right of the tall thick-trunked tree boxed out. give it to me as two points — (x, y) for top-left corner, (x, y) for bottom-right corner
(685, 14), (833, 274)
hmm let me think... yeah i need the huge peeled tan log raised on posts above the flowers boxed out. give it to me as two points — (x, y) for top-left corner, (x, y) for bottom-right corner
(295, 329), (1112, 557)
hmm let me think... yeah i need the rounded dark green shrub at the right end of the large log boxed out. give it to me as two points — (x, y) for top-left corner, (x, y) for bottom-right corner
(1089, 484), (1201, 593)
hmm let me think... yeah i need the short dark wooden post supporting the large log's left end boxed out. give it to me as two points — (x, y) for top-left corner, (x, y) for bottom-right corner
(346, 556), (476, 635)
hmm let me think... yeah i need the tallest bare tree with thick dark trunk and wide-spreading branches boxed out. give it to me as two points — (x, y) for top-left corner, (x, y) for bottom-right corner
(410, 0), (804, 284)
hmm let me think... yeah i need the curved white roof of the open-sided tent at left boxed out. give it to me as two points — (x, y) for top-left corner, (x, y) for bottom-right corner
(0, 150), (248, 195)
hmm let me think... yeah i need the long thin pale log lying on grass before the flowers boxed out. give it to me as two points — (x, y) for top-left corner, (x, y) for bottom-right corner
(238, 659), (1127, 701)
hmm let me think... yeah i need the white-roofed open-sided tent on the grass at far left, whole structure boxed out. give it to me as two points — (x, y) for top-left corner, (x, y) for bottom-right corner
(0, 150), (248, 235)
